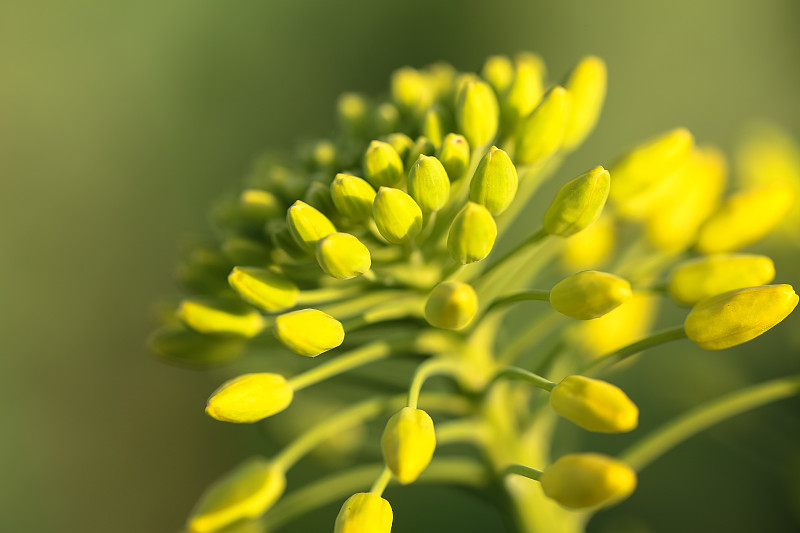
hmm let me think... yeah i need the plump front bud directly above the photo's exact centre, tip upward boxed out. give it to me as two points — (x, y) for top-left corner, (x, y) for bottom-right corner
(372, 187), (422, 244)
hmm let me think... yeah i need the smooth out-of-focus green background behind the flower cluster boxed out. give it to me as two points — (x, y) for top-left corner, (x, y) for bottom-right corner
(0, 0), (800, 533)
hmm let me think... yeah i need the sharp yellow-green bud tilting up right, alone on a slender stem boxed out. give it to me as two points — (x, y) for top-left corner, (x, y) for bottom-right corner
(544, 167), (611, 237)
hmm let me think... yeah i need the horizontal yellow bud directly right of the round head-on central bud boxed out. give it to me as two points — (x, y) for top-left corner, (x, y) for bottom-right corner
(550, 270), (631, 320)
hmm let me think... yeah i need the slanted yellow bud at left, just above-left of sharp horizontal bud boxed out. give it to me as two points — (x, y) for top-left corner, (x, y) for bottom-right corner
(228, 267), (300, 313)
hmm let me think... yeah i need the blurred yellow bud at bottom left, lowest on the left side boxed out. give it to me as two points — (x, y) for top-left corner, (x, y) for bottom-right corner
(186, 457), (286, 533)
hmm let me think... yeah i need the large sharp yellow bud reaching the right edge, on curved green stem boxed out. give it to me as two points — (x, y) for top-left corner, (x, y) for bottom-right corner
(684, 285), (797, 350)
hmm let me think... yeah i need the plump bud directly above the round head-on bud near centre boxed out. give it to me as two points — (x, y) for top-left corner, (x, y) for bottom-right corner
(447, 202), (497, 265)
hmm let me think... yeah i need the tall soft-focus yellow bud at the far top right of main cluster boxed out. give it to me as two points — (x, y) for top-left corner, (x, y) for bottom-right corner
(564, 56), (607, 150)
